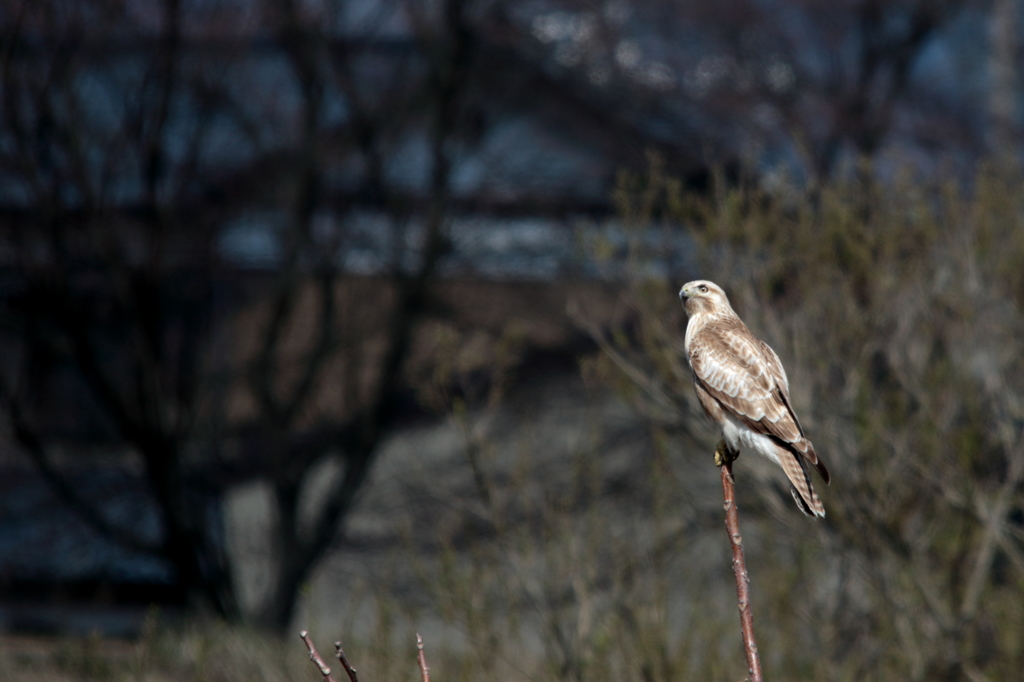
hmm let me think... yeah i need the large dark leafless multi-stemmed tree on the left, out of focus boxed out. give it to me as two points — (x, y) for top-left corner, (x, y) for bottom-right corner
(2, 0), (483, 630)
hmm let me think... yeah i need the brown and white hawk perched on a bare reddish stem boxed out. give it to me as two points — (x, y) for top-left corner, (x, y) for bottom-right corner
(679, 280), (829, 516)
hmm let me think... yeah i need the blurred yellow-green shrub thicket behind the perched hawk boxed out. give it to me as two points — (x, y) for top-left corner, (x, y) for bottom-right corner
(395, 163), (1024, 682)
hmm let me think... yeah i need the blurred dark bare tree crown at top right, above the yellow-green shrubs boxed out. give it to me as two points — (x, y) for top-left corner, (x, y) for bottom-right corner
(534, 0), (982, 180)
